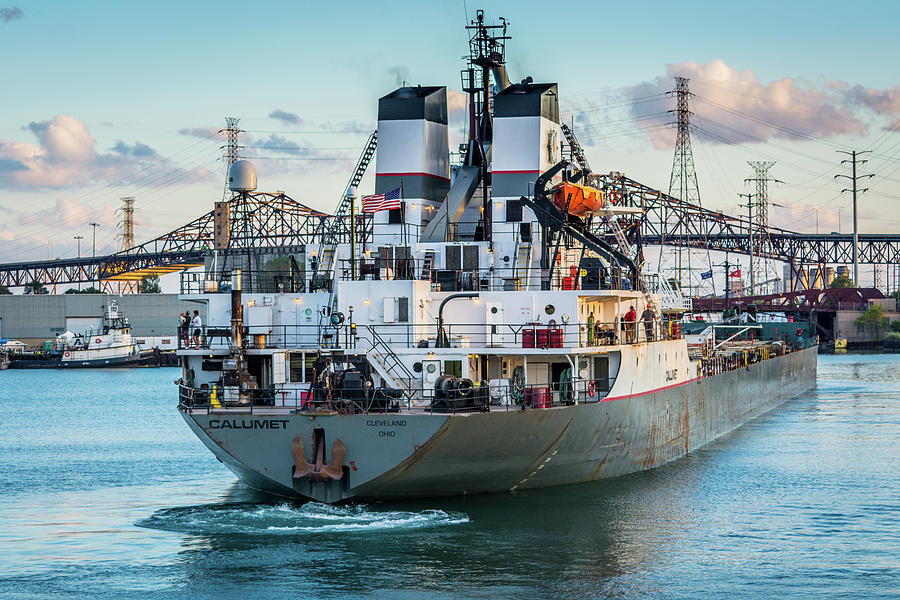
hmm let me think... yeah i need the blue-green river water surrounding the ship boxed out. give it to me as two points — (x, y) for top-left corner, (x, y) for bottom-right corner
(0, 355), (900, 599)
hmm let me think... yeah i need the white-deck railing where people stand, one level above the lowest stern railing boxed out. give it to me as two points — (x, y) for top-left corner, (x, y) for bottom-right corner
(178, 319), (682, 351)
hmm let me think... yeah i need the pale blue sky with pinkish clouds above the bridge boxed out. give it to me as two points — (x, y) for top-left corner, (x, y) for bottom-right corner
(0, 0), (900, 286)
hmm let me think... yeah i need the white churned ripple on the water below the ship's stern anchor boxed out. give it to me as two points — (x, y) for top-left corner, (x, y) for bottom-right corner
(135, 502), (469, 535)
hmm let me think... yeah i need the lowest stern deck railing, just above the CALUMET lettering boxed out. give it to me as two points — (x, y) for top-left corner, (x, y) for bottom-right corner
(178, 377), (615, 414)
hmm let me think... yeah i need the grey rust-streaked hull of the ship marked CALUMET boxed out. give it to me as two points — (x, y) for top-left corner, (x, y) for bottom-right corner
(182, 347), (817, 502)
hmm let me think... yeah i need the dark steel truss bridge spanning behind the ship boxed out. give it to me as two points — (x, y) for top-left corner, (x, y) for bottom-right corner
(0, 173), (900, 287)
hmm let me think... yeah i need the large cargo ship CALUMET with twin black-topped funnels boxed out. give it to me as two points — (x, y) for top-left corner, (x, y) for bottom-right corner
(176, 11), (817, 503)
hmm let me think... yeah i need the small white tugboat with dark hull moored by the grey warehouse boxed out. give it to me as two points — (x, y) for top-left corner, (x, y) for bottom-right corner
(8, 300), (159, 369)
